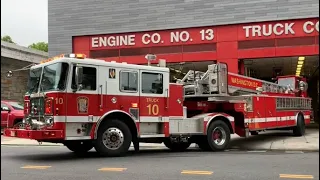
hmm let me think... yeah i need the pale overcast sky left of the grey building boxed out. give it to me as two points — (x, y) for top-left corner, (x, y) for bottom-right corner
(1, 0), (48, 46)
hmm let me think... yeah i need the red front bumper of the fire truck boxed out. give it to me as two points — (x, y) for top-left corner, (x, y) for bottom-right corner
(3, 128), (64, 140)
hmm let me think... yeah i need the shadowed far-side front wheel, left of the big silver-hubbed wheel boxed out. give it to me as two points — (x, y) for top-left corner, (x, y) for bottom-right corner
(64, 141), (93, 155)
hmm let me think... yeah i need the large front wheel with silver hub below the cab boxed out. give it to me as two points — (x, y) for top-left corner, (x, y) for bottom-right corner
(94, 120), (132, 156)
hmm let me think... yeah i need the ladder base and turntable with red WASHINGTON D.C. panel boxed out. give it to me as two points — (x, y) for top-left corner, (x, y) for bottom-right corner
(177, 63), (293, 97)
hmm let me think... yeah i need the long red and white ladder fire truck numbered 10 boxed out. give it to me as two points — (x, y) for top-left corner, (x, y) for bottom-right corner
(4, 54), (312, 156)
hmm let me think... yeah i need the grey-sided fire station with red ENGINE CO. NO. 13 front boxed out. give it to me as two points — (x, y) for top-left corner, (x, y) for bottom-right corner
(48, 0), (319, 122)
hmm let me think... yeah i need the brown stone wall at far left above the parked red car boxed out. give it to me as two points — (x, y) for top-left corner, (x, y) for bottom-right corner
(1, 57), (30, 102)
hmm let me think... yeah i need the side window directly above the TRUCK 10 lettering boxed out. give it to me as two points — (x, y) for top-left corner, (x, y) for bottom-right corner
(141, 72), (163, 94)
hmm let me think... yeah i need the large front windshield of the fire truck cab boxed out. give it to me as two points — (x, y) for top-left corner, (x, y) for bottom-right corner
(40, 63), (69, 92)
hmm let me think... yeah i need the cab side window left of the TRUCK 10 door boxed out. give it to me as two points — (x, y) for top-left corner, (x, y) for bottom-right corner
(120, 71), (138, 92)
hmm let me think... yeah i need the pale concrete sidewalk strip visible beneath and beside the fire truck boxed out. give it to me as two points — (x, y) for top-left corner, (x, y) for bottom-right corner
(1, 129), (319, 151)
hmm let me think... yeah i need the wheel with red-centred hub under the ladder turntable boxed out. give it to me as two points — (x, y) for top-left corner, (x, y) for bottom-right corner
(207, 120), (231, 151)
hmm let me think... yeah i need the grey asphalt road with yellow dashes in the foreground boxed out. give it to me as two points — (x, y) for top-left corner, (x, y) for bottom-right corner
(1, 146), (319, 180)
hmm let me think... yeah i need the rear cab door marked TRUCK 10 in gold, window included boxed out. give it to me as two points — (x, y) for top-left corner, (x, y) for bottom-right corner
(140, 70), (169, 123)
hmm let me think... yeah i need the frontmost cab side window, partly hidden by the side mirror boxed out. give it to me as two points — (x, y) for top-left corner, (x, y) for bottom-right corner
(71, 67), (97, 91)
